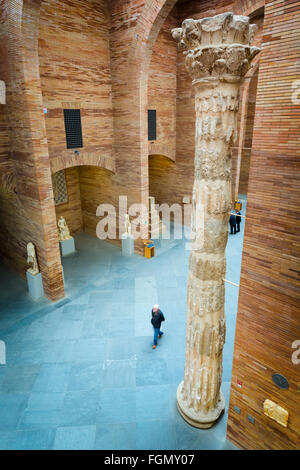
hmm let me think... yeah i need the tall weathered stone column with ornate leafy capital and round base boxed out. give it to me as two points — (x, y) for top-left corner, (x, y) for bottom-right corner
(172, 13), (259, 428)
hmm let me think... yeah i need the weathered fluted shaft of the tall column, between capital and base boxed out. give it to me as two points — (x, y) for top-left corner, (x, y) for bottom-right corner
(182, 83), (239, 413)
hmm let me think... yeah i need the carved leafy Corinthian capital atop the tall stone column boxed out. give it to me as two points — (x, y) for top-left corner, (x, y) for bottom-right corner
(172, 13), (260, 83)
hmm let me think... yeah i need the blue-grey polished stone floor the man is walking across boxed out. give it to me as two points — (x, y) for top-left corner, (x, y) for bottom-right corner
(0, 197), (244, 450)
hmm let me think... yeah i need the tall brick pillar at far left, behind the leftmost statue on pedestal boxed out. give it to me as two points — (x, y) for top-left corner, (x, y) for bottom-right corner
(0, 0), (64, 301)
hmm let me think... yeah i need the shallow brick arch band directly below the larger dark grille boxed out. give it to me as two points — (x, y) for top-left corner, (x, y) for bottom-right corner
(51, 151), (116, 174)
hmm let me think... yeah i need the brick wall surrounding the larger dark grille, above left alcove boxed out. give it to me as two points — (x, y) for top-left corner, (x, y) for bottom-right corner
(39, 0), (113, 173)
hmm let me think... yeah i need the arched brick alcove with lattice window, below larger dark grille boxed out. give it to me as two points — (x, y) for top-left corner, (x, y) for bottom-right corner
(52, 165), (118, 291)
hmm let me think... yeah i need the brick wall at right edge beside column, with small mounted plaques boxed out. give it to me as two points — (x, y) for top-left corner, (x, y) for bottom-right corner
(228, 0), (300, 449)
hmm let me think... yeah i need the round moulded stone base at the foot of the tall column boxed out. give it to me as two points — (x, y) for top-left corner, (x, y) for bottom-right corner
(177, 382), (225, 429)
